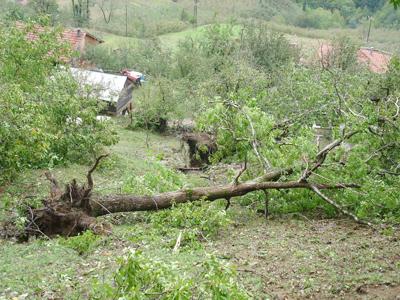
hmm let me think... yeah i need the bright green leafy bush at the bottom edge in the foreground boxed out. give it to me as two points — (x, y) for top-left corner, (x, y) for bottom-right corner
(92, 251), (250, 300)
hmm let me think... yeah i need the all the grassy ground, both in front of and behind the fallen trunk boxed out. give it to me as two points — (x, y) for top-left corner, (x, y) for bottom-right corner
(0, 121), (400, 299)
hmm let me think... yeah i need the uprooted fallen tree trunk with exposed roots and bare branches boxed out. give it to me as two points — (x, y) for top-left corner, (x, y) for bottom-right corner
(20, 135), (365, 238)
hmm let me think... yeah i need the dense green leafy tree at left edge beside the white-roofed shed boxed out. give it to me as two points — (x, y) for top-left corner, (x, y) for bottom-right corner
(0, 24), (116, 180)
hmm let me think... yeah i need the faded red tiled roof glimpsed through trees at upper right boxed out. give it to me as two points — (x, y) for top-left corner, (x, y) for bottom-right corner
(318, 44), (392, 73)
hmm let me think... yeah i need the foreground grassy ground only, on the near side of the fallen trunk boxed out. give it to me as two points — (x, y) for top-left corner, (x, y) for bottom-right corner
(0, 209), (400, 299)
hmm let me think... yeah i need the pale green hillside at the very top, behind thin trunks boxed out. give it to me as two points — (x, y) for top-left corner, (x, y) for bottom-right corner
(58, 0), (299, 37)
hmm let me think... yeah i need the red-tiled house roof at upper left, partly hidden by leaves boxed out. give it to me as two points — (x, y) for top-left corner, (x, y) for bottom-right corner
(16, 22), (104, 53)
